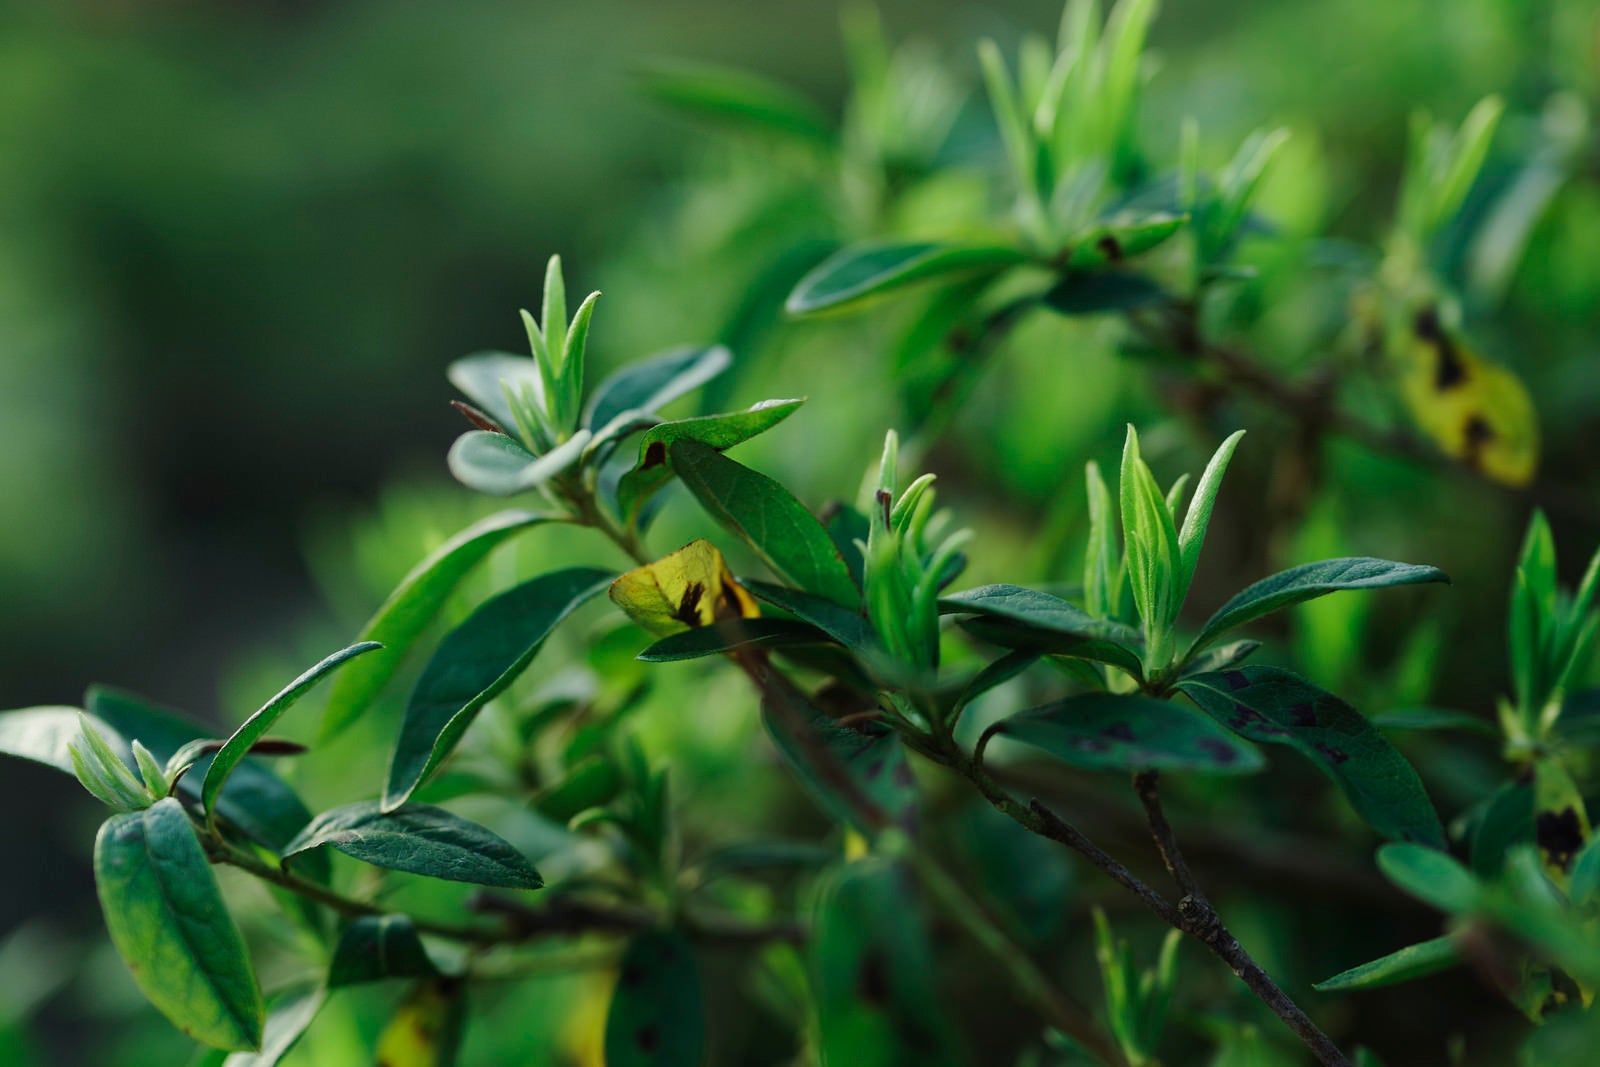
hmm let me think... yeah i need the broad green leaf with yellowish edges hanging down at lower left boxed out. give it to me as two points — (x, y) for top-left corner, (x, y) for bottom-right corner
(94, 797), (266, 1049)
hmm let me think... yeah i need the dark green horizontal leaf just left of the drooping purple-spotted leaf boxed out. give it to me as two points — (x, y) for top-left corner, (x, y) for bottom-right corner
(990, 693), (1262, 774)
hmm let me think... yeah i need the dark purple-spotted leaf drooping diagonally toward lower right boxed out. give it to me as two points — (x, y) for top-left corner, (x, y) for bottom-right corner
(1178, 667), (1445, 848)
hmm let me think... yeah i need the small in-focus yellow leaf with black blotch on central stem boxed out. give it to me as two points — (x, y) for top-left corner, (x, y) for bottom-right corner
(611, 539), (762, 637)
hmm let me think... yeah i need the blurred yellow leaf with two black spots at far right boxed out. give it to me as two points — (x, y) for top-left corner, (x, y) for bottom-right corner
(1402, 309), (1539, 485)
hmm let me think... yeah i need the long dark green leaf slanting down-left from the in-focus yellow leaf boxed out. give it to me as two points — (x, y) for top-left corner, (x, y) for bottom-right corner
(384, 566), (614, 811)
